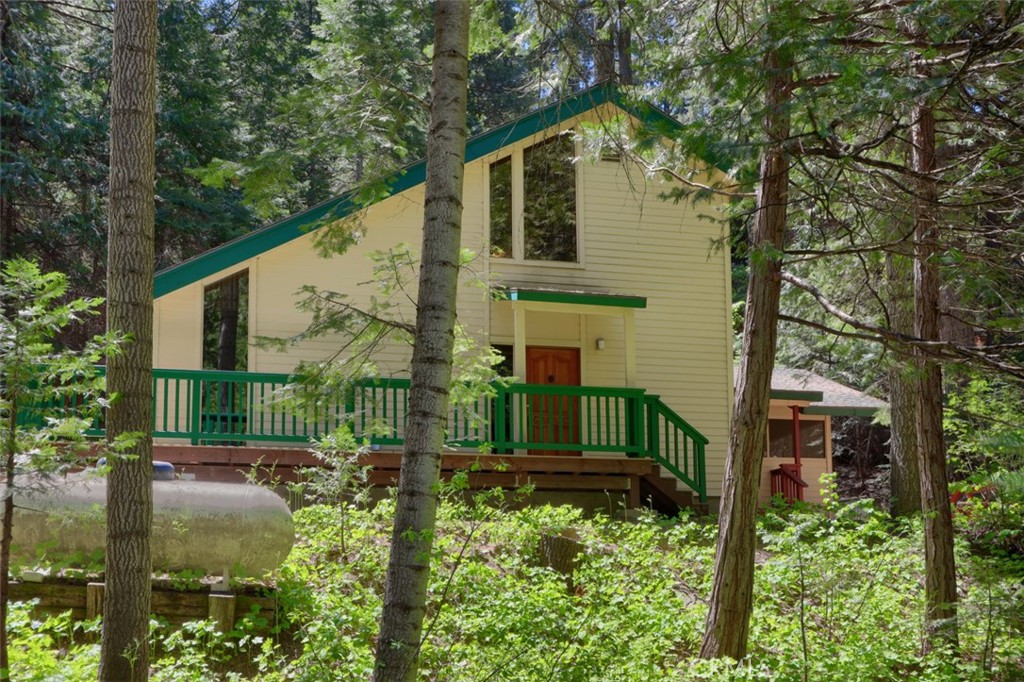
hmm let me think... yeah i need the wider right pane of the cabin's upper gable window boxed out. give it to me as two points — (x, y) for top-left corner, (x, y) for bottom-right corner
(522, 135), (579, 263)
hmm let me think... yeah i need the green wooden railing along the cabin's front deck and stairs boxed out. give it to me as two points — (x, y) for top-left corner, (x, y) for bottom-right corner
(37, 369), (708, 502)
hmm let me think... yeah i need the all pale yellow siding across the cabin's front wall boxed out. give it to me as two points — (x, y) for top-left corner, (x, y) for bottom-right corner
(155, 109), (732, 497)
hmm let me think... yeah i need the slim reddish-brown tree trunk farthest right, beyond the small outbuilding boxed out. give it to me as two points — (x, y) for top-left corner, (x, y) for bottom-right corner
(910, 100), (957, 646)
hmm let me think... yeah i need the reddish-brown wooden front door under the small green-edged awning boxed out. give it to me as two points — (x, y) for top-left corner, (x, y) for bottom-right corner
(526, 346), (581, 455)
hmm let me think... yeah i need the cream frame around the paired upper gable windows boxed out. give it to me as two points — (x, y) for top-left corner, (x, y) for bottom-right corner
(483, 128), (586, 269)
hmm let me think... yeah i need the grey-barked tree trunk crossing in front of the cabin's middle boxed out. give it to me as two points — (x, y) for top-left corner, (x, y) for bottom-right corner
(374, 0), (470, 682)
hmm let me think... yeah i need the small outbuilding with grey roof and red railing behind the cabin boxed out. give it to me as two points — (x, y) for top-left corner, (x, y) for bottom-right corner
(760, 367), (887, 502)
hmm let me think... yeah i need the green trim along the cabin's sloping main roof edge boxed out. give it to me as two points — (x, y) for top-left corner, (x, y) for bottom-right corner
(154, 85), (681, 298)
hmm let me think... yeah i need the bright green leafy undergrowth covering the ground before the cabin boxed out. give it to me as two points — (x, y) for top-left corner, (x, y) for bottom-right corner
(14, 491), (1024, 682)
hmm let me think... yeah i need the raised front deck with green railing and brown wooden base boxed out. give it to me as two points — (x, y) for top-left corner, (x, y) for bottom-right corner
(75, 369), (708, 505)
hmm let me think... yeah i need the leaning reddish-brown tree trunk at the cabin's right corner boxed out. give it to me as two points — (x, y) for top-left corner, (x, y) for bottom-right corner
(700, 38), (793, 659)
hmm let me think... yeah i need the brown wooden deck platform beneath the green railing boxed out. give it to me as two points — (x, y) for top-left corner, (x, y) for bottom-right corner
(154, 444), (654, 507)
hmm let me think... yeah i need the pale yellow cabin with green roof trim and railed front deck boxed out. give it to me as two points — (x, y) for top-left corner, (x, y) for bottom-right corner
(142, 87), (733, 505)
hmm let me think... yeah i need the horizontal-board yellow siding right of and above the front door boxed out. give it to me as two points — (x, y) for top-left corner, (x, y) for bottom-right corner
(478, 150), (732, 497)
